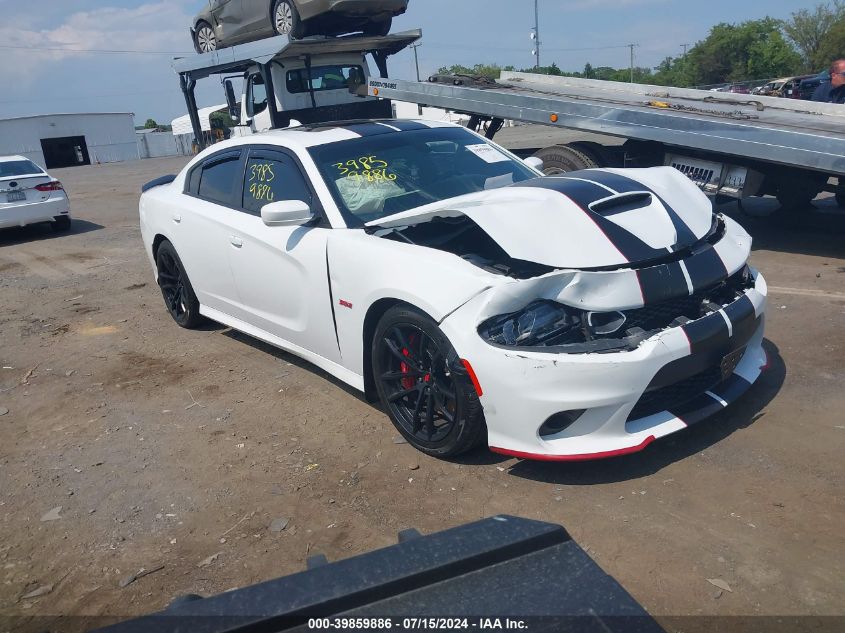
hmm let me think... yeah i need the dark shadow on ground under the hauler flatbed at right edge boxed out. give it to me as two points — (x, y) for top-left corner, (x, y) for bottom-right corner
(717, 197), (845, 257)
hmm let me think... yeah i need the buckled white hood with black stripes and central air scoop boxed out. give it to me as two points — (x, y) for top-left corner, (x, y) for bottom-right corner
(369, 167), (713, 268)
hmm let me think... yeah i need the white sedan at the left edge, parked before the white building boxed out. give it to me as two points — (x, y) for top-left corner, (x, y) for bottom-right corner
(0, 156), (70, 231)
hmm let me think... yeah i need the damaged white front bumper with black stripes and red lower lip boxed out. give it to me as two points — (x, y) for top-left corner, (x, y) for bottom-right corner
(441, 264), (767, 460)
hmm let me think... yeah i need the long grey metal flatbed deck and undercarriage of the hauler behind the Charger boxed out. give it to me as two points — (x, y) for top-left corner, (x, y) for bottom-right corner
(366, 72), (845, 207)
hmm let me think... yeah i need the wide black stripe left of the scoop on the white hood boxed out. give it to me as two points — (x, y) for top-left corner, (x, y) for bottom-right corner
(513, 177), (668, 262)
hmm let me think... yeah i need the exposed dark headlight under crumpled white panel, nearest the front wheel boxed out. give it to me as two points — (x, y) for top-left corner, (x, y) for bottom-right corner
(478, 300), (584, 347)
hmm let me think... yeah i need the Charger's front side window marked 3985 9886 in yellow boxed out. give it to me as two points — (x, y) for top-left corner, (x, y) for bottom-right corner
(241, 150), (312, 215)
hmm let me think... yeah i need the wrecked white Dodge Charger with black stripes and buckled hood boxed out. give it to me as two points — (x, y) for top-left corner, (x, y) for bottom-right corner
(140, 120), (767, 460)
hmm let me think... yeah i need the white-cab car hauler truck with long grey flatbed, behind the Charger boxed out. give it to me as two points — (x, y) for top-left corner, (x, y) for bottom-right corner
(174, 30), (845, 208)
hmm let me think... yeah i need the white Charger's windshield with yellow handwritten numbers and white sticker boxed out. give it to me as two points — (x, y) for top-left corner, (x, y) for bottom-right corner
(309, 123), (537, 227)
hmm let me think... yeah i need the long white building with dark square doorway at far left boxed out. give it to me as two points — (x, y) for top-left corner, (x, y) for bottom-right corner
(0, 112), (138, 169)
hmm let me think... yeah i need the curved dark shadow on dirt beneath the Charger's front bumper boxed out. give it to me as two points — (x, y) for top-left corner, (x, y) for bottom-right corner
(481, 340), (787, 486)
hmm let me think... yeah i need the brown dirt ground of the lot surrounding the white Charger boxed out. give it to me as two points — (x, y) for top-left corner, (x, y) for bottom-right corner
(0, 139), (845, 630)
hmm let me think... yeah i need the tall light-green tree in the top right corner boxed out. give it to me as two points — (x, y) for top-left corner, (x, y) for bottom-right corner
(783, 0), (845, 72)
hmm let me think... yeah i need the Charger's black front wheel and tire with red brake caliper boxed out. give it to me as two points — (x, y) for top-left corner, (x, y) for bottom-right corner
(372, 306), (486, 457)
